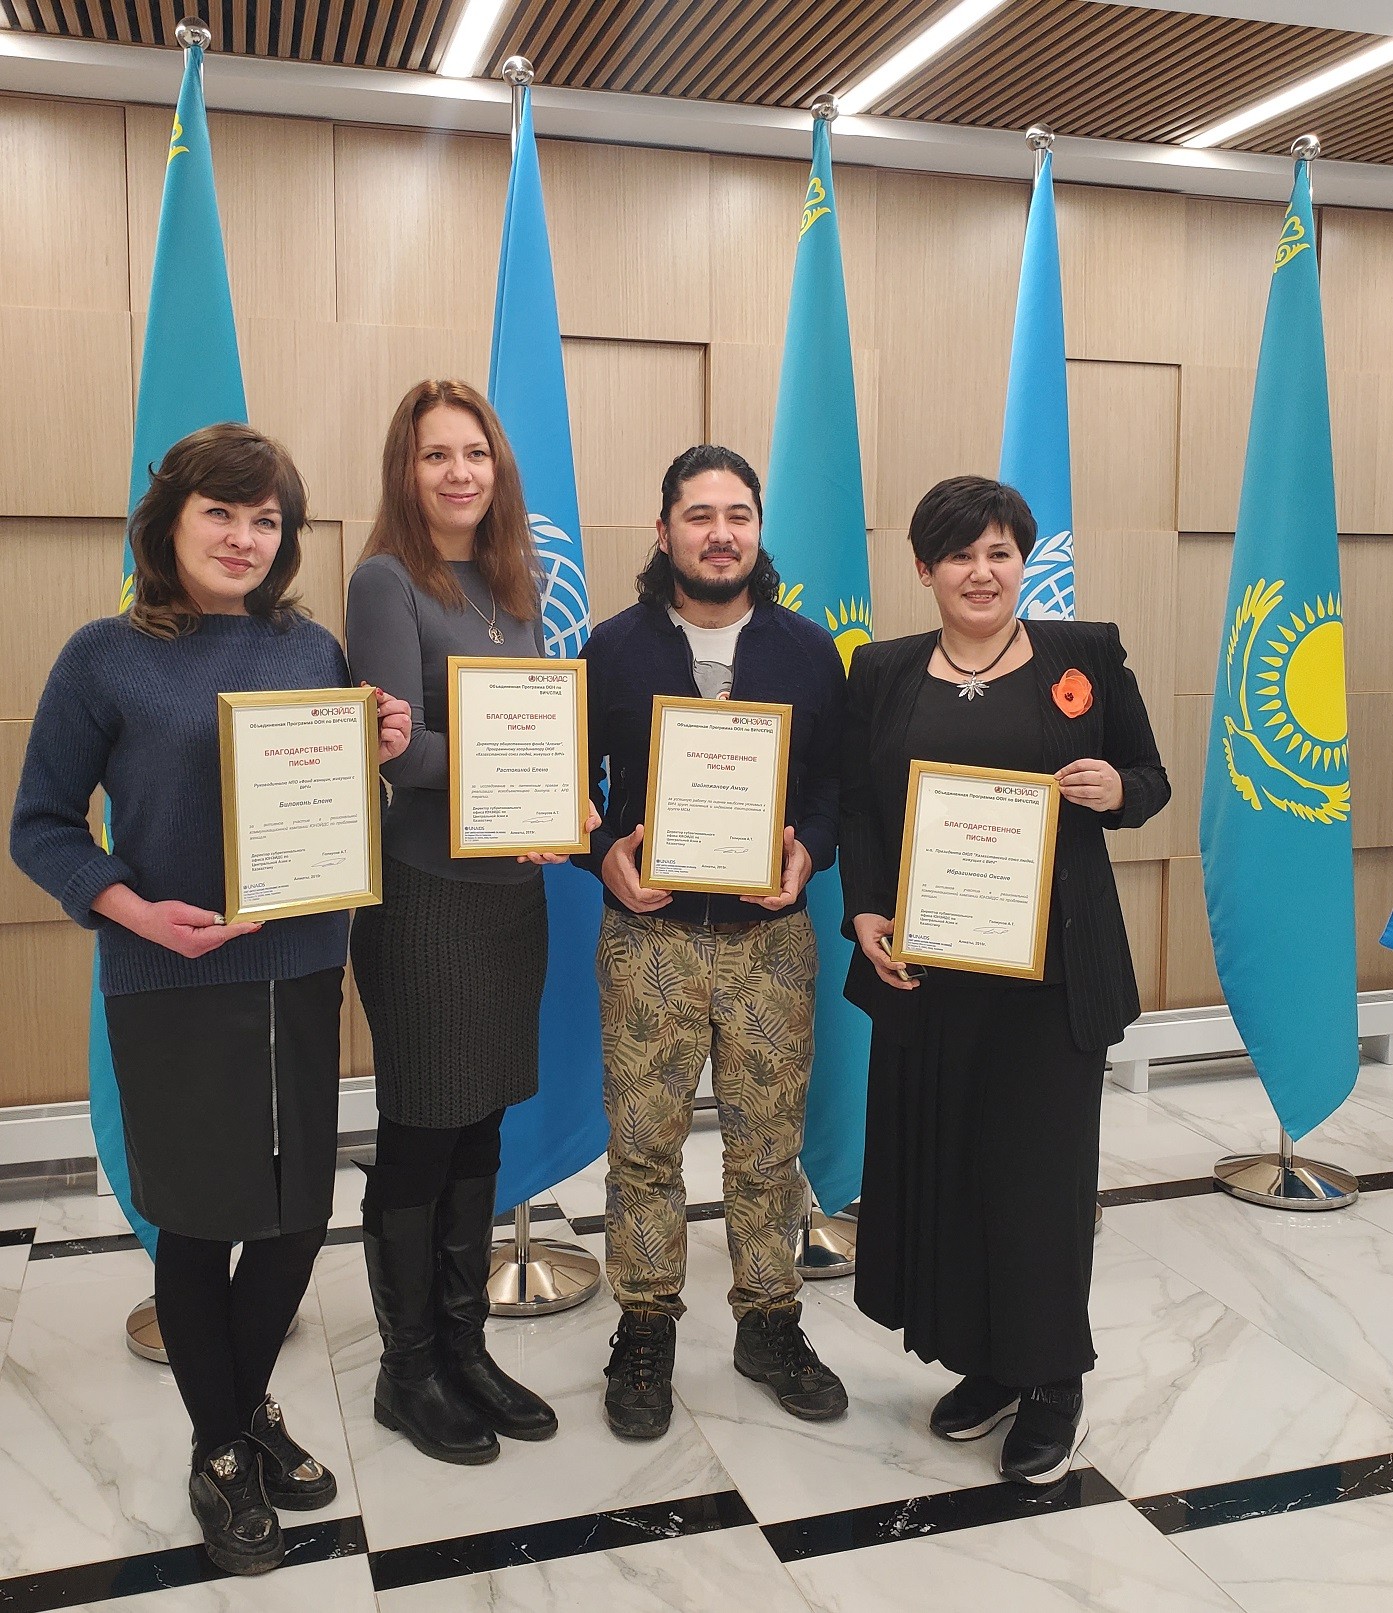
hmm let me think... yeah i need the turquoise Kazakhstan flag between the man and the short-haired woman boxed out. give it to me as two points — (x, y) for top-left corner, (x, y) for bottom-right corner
(764, 118), (871, 1215)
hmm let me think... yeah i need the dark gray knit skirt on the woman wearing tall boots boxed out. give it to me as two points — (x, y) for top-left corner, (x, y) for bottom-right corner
(350, 857), (547, 1127)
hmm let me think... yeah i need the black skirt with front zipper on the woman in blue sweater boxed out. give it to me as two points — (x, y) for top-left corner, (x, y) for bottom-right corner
(106, 968), (343, 1244)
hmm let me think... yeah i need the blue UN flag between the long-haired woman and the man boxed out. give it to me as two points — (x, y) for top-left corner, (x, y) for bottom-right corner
(489, 81), (608, 1211)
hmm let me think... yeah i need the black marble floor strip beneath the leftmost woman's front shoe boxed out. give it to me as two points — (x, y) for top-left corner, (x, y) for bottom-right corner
(0, 1518), (368, 1613)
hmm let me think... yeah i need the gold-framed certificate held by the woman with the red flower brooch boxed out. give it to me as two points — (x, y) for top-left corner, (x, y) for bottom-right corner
(892, 761), (1059, 981)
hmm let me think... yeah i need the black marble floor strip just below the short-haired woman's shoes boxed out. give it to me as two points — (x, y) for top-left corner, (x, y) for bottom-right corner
(764, 1468), (1124, 1563)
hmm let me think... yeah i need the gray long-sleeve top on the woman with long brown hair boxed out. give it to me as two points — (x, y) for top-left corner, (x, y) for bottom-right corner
(343, 555), (545, 886)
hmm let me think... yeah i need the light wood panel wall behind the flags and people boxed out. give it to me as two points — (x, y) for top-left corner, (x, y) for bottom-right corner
(0, 97), (1393, 1105)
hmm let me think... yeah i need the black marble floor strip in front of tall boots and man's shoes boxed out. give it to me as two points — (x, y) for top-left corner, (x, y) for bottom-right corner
(367, 1490), (755, 1587)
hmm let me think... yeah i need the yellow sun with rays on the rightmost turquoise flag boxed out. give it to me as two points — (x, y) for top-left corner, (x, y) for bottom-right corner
(1254, 595), (1349, 773)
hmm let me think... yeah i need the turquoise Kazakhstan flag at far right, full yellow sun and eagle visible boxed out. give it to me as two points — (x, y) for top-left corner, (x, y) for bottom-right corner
(1200, 163), (1359, 1137)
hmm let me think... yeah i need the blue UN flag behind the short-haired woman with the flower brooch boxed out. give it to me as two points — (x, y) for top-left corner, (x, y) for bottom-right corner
(1001, 152), (1074, 621)
